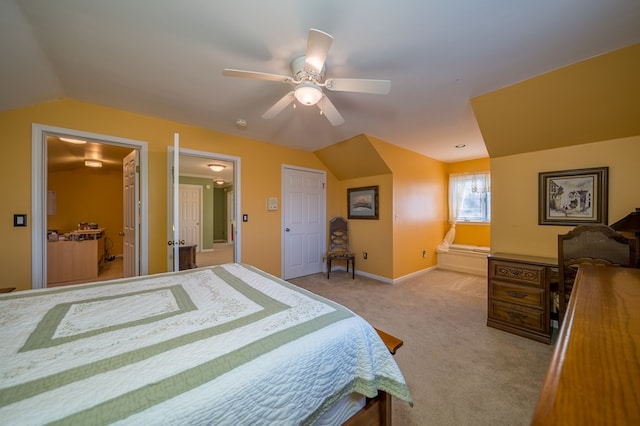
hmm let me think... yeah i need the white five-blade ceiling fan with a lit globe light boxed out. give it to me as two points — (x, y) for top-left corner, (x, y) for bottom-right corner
(222, 28), (391, 126)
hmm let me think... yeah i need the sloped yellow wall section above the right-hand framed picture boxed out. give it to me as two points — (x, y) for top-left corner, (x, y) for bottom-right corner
(471, 43), (640, 158)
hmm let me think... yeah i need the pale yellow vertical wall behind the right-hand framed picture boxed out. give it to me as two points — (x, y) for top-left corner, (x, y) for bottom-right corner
(491, 136), (640, 258)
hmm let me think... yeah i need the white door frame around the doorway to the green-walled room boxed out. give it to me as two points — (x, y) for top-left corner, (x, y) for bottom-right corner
(167, 145), (242, 271)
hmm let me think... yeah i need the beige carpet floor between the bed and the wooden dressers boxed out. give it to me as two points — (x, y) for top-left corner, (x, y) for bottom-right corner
(290, 269), (553, 426)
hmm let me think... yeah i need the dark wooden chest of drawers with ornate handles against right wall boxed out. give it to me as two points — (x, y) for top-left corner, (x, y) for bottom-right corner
(487, 253), (558, 344)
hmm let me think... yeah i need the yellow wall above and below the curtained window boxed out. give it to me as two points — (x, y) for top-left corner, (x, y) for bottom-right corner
(446, 158), (493, 247)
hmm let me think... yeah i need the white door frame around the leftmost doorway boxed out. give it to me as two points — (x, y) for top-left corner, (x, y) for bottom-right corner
(31, 123), (149, 289)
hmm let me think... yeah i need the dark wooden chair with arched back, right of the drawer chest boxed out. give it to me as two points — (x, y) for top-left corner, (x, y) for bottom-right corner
(558, 225), (636, 323)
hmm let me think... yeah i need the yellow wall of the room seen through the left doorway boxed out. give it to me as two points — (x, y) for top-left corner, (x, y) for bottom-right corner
(47, 168), (123, 255)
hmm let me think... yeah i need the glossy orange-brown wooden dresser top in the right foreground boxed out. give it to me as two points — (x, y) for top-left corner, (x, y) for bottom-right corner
(531, 265), (640, 425)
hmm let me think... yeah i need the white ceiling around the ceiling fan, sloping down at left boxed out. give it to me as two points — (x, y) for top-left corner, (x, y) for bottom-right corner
(0, 0), (640, 162)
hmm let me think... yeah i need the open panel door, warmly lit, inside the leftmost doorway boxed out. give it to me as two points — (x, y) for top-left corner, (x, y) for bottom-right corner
(122, 150), (140, 278)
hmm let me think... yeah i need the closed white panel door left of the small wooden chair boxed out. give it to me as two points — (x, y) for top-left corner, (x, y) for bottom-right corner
(282, 167), (326, 279)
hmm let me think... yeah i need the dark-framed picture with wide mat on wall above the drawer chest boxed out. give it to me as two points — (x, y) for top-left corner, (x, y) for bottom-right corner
(538, 167), (609, 225)
